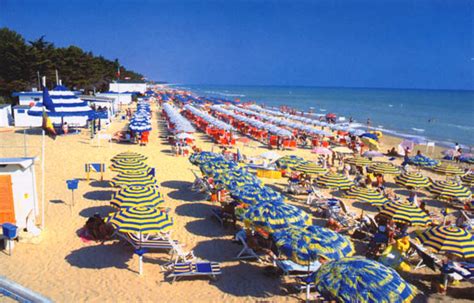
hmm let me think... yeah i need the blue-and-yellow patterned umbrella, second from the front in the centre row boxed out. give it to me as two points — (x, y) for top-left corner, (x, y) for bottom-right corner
(272, 225), (355, 265)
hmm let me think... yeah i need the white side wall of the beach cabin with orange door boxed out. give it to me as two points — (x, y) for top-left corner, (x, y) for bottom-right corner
(0, 164), (39, 229)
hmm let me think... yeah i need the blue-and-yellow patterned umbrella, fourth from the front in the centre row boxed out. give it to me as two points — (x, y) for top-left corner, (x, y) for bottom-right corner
(230, 184), (283, 205)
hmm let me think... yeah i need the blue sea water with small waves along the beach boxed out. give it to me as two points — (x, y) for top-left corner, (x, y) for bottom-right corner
(178, 85), (474, 147)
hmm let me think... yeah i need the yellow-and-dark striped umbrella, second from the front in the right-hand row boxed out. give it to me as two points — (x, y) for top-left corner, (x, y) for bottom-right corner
(380, 202), (432, 226)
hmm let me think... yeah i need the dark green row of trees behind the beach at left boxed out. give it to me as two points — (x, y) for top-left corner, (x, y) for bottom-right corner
(0, 28), (143, 103)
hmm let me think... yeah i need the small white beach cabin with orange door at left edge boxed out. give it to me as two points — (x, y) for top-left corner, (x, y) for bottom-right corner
(0, 158), (39, 230)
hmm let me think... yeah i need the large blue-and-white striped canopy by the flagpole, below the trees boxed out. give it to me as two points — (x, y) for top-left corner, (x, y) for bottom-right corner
(28, 86), (94, 126)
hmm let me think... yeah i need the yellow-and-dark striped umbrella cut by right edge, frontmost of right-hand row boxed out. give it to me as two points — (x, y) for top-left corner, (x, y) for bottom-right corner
(418, 226), (474, 259)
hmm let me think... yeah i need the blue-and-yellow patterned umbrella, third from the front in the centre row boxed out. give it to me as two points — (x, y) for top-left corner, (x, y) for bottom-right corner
(243, 203), (312, 233)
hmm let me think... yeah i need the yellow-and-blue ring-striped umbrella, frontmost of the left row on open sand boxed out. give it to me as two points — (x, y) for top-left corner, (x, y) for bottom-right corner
(106, 207), (173, 234)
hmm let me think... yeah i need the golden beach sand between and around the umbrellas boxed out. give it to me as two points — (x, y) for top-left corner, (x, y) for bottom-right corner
(0, 105), (474, 302)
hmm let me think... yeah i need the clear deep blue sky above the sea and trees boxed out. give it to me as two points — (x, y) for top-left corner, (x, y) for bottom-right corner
(0, 0), (474, 89)
